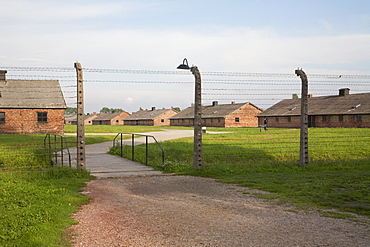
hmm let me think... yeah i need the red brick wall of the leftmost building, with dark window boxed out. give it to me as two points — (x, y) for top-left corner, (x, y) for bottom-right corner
(0, 109), (64, 135)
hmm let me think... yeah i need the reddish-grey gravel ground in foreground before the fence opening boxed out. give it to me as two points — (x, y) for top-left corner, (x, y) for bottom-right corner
(72, 176), (370, 247)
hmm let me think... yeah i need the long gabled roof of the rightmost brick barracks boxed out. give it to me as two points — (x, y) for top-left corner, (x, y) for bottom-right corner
(257, 93), (370, 117)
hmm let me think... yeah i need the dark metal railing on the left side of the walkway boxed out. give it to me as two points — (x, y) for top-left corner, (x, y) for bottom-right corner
(44, 134), (72, 167)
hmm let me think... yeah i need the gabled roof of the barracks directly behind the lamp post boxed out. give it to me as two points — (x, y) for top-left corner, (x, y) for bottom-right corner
(170, 102), (262, 119)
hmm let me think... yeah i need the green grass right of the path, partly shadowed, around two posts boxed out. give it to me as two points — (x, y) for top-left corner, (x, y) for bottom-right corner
(112, 128), (370, 217)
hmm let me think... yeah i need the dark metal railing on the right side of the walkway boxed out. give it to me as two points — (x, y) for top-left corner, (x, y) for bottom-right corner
(113, 133), (164, 165)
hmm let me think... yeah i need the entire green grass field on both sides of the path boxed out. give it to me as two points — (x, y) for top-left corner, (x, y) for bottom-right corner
(0, 126), (370, 246)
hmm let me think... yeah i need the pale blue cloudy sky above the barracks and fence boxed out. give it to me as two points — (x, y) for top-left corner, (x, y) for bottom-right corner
(0, 0), (370, 112)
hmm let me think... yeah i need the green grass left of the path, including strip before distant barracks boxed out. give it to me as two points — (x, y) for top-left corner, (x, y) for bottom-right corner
(0, 126), (170, 247)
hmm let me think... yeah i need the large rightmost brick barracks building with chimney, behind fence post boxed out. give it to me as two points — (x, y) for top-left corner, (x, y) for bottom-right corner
(257, 88), (370, 128)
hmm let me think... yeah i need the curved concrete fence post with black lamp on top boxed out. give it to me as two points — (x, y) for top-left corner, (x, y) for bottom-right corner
(177, 58), (202, 169)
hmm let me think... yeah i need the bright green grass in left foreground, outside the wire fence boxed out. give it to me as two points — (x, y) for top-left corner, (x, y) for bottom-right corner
(0, 167), (91, 247)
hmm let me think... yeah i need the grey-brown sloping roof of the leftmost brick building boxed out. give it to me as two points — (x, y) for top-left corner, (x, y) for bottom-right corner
(0, 80), (66, 109)
